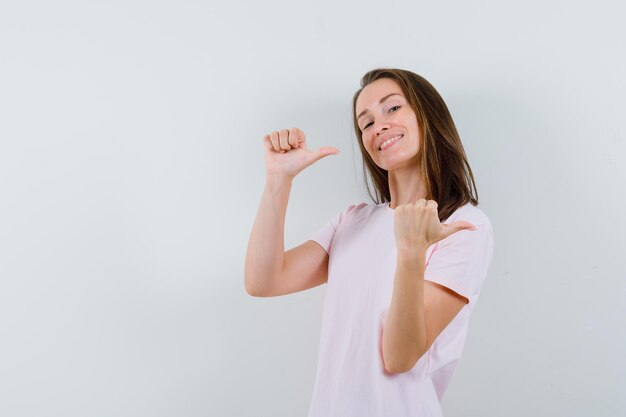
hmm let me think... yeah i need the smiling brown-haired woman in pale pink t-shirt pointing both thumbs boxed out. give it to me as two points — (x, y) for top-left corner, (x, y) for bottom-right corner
(245, 68), (494, 417)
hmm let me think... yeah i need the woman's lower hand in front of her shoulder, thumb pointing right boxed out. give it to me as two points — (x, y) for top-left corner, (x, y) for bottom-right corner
(394, 198), (476, 251)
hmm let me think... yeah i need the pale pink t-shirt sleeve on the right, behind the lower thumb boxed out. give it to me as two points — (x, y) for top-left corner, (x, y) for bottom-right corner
(424, 221), (494, 303)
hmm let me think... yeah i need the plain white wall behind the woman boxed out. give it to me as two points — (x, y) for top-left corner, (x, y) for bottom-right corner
(0, 0), (626, 417)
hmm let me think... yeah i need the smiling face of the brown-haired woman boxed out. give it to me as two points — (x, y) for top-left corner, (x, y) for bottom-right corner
(356, 78), (421, 171)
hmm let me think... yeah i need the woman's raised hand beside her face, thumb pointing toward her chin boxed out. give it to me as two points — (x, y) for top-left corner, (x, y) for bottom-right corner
(263, 127), (339, 179)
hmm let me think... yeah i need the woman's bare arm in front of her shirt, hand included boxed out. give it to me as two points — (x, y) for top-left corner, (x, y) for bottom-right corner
(382, 199), (476, 373)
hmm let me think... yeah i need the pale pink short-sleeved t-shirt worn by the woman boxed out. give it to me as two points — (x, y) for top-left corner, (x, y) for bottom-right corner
(309, 203), (494, 417)
